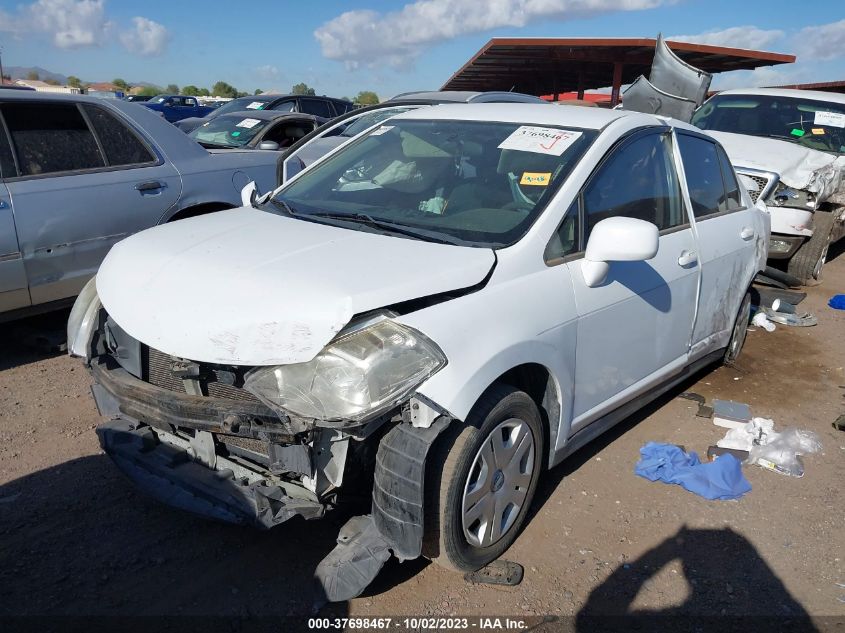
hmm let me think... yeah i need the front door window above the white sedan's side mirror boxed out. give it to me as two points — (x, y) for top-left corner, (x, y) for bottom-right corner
(584, 134), (686, 237)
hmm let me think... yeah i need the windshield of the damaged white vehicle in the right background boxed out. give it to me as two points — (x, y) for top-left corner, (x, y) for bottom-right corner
(692, 95), (845, 154)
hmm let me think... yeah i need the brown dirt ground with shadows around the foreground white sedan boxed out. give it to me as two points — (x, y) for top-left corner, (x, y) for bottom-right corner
(0, 249), (845, 630)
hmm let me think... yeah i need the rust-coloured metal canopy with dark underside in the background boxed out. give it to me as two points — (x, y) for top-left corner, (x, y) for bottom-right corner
(442, 37), (795, 104)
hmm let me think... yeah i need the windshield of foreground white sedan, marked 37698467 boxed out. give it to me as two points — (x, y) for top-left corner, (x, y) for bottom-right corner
(274, 120), (597, 247)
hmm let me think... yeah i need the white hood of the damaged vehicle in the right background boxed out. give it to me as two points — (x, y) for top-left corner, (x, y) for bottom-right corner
(707, 130), (845, 201)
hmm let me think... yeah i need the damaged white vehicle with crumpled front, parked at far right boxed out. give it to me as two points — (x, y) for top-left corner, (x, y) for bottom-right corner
(692, 88), (845, 282)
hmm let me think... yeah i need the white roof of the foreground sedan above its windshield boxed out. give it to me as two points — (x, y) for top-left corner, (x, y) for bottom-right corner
(393, 103), (664, 130)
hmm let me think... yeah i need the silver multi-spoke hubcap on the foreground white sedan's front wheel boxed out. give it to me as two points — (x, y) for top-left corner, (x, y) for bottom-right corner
(461, 419), (534, 547)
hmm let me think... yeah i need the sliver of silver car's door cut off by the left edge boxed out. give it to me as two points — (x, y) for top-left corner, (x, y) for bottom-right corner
(0, 120), (30, 315)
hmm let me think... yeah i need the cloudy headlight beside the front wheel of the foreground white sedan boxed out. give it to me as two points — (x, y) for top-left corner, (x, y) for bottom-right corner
(244, 319), (446, 425)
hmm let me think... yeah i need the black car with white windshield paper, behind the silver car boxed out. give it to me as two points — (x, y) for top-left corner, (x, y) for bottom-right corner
(188, 110), (326, 150)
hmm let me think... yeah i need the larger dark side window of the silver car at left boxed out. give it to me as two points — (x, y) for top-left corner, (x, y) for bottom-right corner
(3, 103), (106, 176)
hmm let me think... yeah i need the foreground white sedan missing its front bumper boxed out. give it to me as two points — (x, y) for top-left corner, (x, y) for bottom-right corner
(68, 104), (769, 600)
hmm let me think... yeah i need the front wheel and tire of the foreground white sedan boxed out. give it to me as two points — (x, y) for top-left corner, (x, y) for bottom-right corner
(423, 384), (545, 571)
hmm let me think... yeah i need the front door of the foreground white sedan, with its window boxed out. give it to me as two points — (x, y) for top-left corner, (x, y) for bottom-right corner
(567, 130), (699, 432)
